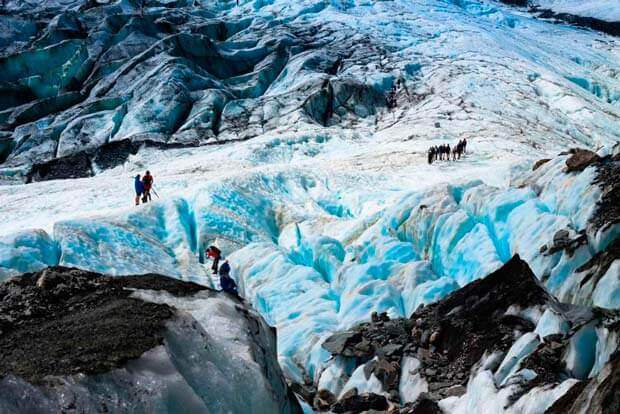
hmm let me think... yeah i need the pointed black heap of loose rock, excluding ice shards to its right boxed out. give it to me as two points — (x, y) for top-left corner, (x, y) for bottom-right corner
(324, 256), (554, 406)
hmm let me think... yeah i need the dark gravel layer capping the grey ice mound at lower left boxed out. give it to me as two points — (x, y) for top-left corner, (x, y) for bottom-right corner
(0, 267), (205, 382)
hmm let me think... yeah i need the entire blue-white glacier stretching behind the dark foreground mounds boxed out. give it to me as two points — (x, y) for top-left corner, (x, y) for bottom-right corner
(0, 0), (620, 413)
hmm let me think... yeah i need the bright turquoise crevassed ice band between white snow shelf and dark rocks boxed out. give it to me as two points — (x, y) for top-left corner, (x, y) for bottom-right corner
(0, 150), (620, 388)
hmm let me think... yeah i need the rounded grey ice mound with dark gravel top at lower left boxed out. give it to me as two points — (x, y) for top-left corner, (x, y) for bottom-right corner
(0, 267), (300, 413)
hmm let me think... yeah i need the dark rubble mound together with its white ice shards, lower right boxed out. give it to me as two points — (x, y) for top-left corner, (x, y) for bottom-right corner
(317, 256), (620, 413)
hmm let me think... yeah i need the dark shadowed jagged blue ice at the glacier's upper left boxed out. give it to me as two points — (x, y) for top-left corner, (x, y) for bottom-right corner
(0, 0), (391, 181)
